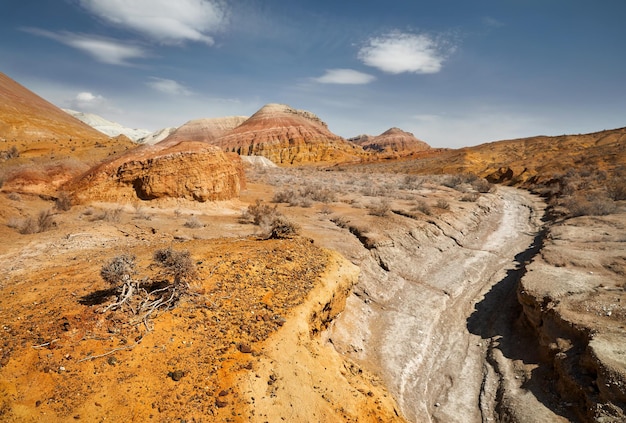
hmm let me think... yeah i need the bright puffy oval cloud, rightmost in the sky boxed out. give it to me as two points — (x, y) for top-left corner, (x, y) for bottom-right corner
(358, 31), (452, 74)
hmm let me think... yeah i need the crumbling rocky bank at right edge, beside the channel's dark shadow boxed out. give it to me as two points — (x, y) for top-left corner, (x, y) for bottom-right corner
(518, 215), (626, 422)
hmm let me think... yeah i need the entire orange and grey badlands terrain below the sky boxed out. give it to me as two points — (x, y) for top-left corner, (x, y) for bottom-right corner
(0, 74), (626, 422)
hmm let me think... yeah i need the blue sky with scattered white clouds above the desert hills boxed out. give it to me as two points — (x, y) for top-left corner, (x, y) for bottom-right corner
(0, 0), (626, 148)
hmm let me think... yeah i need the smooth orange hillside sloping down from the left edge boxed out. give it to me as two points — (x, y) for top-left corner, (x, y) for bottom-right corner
(0, 73), (135, 195)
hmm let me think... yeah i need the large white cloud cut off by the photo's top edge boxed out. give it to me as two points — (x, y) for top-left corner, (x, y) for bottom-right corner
(79, 0), (228, 45)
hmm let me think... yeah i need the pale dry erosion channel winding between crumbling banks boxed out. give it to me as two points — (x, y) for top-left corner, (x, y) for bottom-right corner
(326, 187), (563, 422)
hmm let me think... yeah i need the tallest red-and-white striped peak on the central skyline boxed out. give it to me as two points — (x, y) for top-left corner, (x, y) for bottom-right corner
(213, 104), (365, 165)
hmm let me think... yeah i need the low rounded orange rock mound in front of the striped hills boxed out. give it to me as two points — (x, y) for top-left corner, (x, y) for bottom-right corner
(68, 142), (244, 202)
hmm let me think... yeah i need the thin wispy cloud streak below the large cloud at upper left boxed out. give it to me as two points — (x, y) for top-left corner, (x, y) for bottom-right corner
(23, 28), (148, 65)
